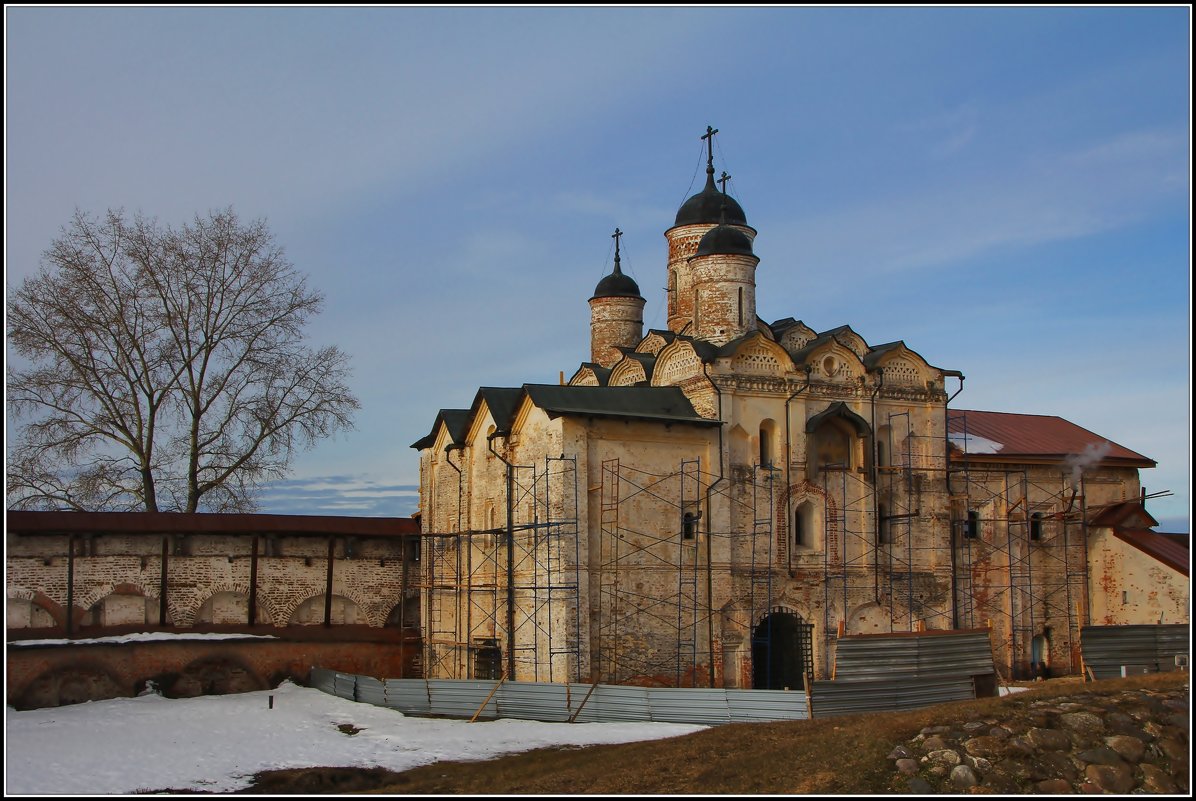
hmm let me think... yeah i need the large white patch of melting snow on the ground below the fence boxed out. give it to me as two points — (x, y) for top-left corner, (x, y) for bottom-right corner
(5, 683), (706, 796)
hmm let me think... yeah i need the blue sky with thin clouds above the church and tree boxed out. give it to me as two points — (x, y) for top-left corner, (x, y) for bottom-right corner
(5, 6), (1191, 530)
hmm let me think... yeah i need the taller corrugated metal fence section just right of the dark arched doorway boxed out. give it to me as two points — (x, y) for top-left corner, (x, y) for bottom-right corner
(810, 629), (995, 717)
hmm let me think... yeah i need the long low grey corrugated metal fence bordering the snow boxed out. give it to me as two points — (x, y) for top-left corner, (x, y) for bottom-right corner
(311, 667), (810, 726)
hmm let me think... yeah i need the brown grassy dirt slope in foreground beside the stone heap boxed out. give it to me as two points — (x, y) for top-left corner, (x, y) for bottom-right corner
(224, 673), (1189, 795)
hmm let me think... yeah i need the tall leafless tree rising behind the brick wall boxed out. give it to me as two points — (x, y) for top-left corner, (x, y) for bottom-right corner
(7, 209), (359, 512)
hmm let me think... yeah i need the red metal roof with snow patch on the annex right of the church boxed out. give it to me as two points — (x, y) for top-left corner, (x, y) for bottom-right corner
(947, 409), (1157, 467)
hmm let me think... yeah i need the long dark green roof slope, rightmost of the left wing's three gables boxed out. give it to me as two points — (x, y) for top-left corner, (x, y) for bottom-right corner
(523, 384), (720, 426)
